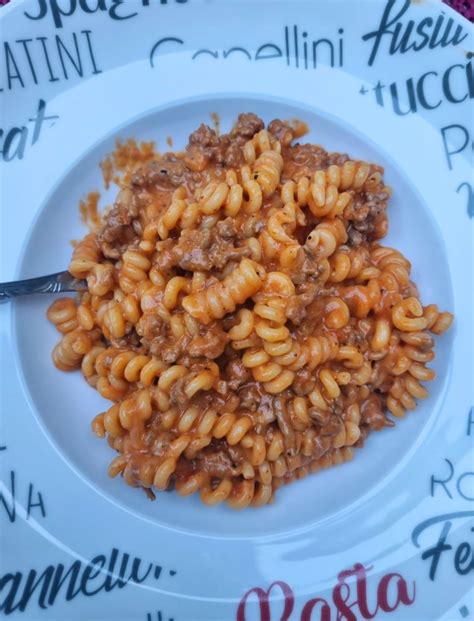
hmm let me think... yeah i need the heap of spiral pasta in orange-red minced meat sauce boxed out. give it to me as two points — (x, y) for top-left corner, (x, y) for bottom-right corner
(48, 114), (452, 509)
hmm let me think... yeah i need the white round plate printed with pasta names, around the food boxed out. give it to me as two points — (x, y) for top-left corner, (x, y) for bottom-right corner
(0, 0), (474, 621)
